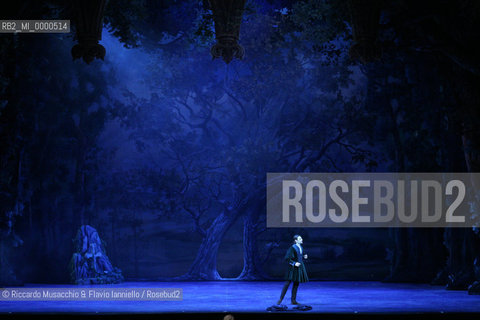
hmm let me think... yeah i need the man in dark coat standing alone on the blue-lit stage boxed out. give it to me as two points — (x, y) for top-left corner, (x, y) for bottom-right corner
(277, 234), (308, 305)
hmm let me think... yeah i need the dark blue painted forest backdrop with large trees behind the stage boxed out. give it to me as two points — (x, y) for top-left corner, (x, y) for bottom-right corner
(0, 0), (480, 294)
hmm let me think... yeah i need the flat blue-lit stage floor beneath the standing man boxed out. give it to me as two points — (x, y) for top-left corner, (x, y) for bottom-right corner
(0, 281), (480, 314)
